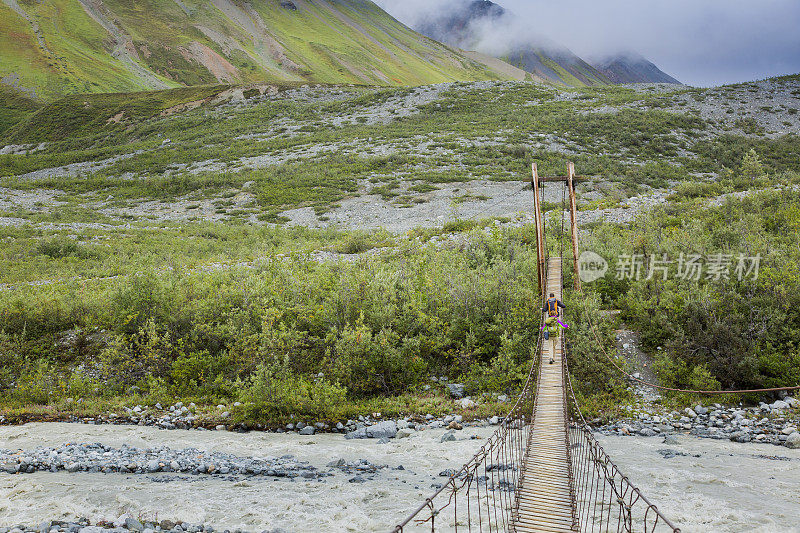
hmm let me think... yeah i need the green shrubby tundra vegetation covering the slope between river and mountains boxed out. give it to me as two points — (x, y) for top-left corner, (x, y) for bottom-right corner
(0, 77), (800, 423)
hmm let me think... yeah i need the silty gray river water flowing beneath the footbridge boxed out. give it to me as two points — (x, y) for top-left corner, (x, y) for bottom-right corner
(0, 423), (800, 533)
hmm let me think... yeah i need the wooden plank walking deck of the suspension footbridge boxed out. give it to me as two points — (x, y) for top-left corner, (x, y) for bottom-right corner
(514, 257), (576, 533)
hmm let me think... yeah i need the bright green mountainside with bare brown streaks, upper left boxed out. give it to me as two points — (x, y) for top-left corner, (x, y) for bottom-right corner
(0, 0), (507, 99)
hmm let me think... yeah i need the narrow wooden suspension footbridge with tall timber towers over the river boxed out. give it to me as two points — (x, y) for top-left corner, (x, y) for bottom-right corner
(392, 163), (680, 533)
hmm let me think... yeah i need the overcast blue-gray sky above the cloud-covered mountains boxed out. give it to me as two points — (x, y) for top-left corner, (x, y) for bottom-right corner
(377, 0), (800, 86)
